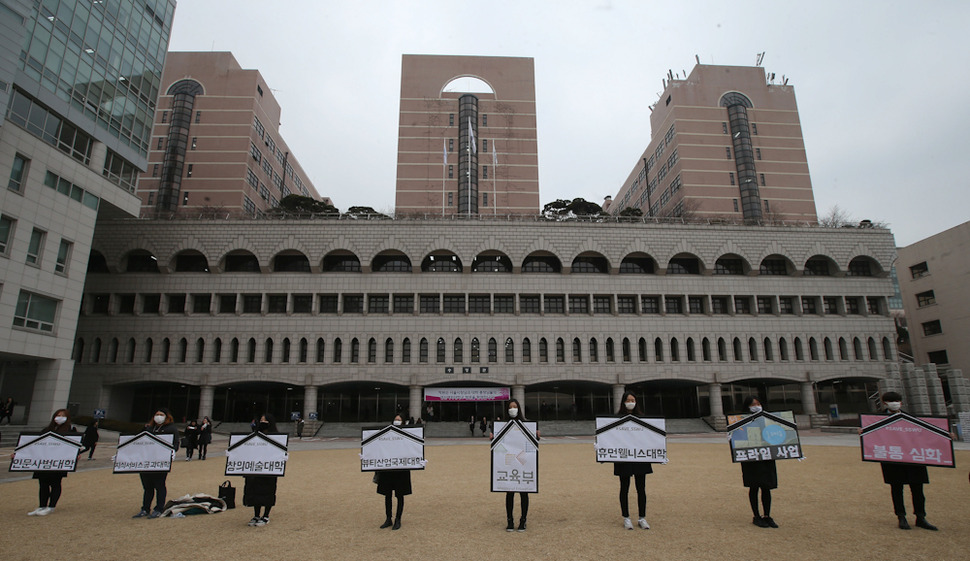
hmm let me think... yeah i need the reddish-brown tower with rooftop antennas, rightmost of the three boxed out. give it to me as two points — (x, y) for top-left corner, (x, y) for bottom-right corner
(609, 64), (817, 223)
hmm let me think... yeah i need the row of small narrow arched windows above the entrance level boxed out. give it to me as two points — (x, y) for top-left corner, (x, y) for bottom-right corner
(74, 336), (894, 364)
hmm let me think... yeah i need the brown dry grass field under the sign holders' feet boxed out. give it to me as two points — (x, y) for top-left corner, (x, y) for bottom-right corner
(0, 442), (970, 561)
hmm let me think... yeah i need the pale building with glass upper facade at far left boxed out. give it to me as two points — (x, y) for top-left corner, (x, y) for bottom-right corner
(0, 0), (175, 425)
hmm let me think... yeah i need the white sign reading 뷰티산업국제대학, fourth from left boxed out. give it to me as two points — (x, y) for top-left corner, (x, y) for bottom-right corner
(360, 425), (425, 471)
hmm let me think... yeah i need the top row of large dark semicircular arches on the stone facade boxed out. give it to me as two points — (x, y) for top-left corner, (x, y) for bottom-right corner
(88, 249), (885, 277)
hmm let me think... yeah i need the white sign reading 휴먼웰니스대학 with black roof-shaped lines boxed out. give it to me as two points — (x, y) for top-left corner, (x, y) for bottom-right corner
(594, 415), (667, 464)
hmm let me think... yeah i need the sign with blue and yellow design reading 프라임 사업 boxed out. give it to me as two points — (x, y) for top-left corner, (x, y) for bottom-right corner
(727, 411), (802, 463)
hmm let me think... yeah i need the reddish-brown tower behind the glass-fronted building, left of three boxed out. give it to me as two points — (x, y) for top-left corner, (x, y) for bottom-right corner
(138, 52), (329, 218)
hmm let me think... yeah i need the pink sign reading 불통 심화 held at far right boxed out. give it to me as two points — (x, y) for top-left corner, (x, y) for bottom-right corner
(859, 411), (957, 467)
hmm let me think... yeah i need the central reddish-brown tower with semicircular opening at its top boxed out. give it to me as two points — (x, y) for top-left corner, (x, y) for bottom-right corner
(395, 55), (539, 216)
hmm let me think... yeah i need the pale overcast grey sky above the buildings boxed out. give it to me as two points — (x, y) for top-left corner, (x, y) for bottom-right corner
(163, 0), (970, 246)
